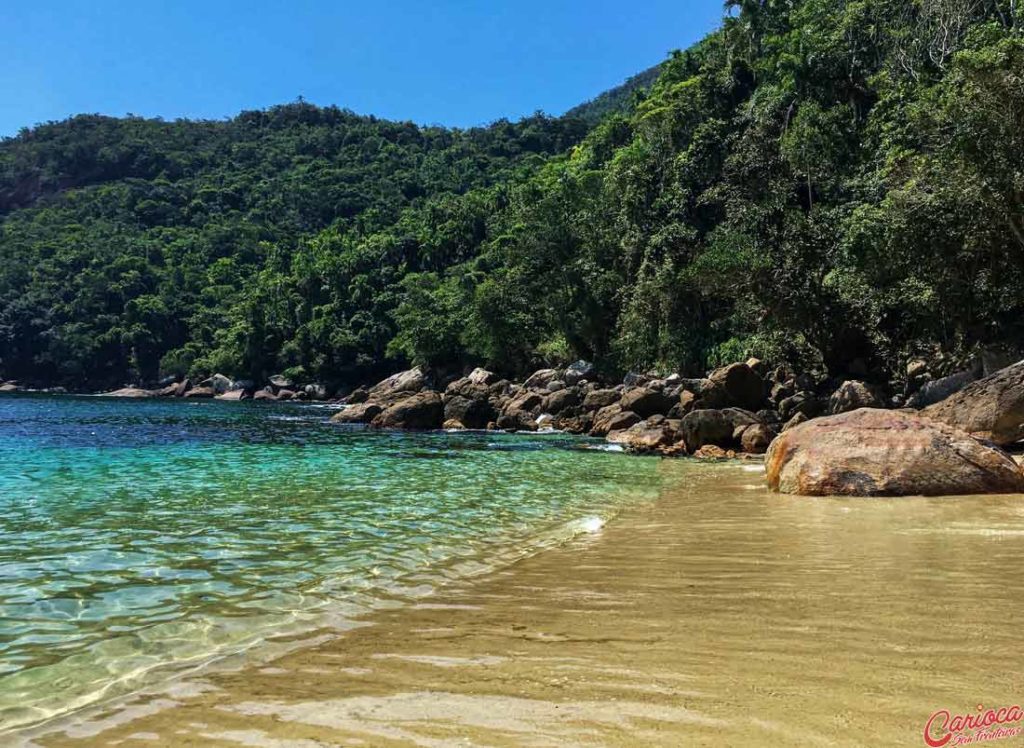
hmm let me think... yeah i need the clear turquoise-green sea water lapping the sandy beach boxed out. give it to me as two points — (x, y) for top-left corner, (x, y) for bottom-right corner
(0, 396), (657, 730)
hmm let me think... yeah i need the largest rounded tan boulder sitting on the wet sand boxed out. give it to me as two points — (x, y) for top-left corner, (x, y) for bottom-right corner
(766, 408), (1024, 496)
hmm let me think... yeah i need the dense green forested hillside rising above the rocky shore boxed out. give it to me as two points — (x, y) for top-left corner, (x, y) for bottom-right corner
(0, 0), (1024, 386)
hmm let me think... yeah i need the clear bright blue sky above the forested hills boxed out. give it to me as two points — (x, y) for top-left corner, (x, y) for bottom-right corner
(0, 0), (722, 136)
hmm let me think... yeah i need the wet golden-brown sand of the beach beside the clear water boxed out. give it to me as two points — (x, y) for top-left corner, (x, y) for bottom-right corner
(18, 461), (1024, 748)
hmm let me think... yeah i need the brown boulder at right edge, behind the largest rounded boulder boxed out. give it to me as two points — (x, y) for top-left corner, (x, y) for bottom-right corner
(921, 361), (1024, 445)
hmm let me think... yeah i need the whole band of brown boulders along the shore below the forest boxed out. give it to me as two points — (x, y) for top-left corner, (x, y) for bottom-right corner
(0, 359), (1024, 495)
